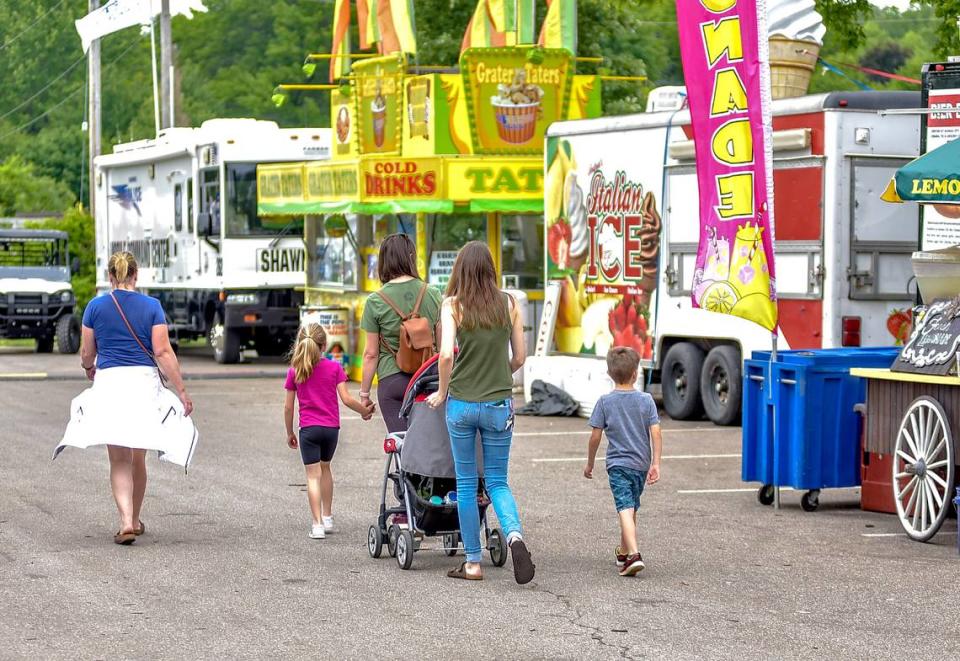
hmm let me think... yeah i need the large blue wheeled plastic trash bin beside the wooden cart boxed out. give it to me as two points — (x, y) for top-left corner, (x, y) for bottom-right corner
(741, 347), (899, 510)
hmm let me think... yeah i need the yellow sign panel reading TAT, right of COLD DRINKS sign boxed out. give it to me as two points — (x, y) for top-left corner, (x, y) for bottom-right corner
(446, 158), (543, 202)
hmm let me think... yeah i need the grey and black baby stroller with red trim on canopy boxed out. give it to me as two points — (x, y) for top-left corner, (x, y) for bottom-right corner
(367, 356), (507, 569)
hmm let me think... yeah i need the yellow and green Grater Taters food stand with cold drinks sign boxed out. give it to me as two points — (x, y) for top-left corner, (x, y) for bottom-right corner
(257, 46), (600, 379)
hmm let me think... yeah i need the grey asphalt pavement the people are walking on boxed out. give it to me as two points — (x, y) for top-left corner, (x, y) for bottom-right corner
(0, 368), (960, 659)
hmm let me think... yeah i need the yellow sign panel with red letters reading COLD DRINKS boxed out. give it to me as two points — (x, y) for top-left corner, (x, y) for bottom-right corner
(360, 158), (443, 200)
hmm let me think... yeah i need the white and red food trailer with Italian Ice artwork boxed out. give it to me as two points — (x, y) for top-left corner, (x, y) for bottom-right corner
(524, 92), (920, 424)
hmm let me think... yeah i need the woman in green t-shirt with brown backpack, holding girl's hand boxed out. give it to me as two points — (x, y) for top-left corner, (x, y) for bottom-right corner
(360, 234), (441, 433)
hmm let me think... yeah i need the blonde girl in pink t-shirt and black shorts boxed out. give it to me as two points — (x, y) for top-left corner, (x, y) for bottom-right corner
(283, 322), (374, 539)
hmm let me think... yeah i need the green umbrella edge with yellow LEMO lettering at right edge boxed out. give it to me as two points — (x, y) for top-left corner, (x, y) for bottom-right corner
(880, 139), (960, 218)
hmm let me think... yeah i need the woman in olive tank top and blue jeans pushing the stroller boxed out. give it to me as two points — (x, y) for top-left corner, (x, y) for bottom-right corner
(427, 241), (535, 584)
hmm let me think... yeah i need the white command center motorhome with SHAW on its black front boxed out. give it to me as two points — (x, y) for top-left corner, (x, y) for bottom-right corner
(95, 119), (331, 363)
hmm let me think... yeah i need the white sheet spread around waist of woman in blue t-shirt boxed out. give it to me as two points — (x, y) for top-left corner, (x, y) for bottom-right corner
(53, 367), (199, 469)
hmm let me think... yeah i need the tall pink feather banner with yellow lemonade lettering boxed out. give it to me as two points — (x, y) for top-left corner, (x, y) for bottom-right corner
(677, 0), (777, 330)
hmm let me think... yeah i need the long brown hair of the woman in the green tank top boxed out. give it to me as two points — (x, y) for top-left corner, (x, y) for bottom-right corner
(447, 241), (510, 330)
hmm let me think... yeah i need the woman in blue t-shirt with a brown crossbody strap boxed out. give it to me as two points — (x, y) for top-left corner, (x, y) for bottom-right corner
(80, 252), (193, 545)
